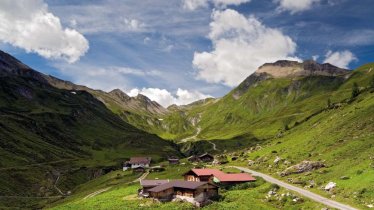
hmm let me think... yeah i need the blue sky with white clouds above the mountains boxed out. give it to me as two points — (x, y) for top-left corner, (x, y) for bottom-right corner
(0, 0), (374, 107)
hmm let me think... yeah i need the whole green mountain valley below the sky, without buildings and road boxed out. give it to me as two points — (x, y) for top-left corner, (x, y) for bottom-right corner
(0, 52), (374, 209)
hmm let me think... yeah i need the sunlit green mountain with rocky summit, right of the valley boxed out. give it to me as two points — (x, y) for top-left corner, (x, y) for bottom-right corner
(158, 61), (374, 209)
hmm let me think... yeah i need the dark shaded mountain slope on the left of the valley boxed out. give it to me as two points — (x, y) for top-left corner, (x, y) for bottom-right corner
(0, 52), (179, 208)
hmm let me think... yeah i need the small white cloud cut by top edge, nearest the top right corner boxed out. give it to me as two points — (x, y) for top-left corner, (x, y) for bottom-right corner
(275, 0), (321, 14)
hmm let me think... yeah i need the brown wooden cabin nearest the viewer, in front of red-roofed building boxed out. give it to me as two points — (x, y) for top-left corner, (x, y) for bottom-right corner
(148, 180), (218, 204)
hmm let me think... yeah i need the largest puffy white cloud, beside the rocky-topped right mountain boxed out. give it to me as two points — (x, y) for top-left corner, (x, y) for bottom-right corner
(193, 9), (298, 86)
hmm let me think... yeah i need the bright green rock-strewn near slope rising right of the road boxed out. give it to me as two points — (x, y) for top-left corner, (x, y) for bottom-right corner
(241, 64), (374, 208)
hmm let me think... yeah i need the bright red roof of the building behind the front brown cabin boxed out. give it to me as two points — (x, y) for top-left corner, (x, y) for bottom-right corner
(192, 169), (256, 182)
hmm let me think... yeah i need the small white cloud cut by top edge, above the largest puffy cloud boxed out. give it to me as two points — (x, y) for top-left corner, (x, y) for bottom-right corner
(183, 0), (251, 10)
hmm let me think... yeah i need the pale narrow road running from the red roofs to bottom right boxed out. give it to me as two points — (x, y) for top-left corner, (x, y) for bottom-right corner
(232, 166), (357, 210)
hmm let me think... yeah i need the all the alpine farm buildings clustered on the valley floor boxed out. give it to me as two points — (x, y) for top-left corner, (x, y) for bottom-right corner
(123, 154), (256, 206)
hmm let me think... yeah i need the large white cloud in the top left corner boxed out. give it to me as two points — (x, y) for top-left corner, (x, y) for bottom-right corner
(0, 0), (89, 63)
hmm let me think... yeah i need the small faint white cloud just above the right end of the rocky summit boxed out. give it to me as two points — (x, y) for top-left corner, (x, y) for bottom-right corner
(323, 50), (357, 69)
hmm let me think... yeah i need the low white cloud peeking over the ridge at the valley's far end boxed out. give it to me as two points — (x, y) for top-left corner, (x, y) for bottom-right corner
(127, 88), (212, 107)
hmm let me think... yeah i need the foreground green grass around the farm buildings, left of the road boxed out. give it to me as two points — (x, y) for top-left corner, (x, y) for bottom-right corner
(49, 165), (323, 209)
